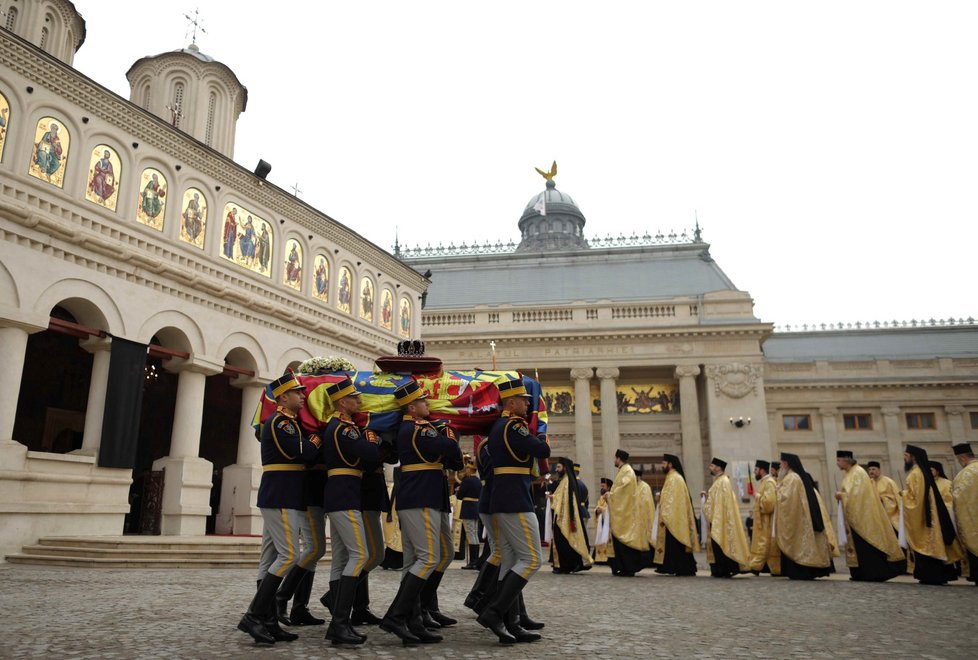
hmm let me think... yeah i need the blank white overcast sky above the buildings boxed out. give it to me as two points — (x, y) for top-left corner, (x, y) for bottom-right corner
(65, 0), (978, 325)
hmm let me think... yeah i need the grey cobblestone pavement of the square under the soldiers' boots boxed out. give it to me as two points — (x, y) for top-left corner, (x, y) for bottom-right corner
(0, 558), (978, 659)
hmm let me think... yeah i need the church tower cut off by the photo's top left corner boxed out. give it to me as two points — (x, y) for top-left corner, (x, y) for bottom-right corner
(0, 0), (85, 66)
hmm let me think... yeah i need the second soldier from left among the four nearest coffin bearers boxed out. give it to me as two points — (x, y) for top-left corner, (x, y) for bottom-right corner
(323, 378), (380, 644)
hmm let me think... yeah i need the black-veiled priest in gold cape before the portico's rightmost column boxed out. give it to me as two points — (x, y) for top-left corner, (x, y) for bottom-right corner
(655, 454), (700, 575)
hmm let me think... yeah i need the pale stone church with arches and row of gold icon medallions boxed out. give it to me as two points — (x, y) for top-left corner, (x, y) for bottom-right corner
(0, 0), (426, 557)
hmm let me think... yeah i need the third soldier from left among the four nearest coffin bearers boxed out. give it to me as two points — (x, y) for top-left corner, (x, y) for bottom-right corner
(380, 380), (462, 644)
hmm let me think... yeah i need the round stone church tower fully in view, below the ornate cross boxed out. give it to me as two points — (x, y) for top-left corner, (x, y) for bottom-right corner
(126, 44), (248, 158)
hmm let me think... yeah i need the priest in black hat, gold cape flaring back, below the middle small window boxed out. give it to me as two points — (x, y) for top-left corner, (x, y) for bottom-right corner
(835, 450), (906, 582)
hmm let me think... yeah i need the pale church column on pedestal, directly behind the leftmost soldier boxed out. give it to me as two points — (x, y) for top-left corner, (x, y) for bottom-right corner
(216, 377), (263, 534)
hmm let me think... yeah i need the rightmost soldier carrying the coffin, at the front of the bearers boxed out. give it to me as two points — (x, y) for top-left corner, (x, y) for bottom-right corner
(478, 378), (550, 644)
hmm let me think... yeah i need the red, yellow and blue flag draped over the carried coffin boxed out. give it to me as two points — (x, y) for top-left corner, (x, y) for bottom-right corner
(253, 370), (547, 471)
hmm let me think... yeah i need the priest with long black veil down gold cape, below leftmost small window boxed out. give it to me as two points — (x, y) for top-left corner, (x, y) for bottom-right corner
(774, 453), (839, 580)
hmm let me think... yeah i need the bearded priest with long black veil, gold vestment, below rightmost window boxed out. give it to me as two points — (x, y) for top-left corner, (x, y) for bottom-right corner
(903, 445), (955, 584)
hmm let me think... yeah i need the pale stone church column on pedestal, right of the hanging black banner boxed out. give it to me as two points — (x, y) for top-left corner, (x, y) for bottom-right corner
(153, 356), (223, 536)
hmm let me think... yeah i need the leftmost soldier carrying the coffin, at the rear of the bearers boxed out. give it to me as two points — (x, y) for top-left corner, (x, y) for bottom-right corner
(238, 373), (321, 643)
